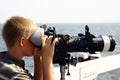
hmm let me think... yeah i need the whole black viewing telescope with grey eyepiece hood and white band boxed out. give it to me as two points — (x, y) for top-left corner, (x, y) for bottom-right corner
(31, 25), (116, 58)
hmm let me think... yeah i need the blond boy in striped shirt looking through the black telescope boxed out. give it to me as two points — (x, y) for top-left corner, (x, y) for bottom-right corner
(0, 16), (56, 80)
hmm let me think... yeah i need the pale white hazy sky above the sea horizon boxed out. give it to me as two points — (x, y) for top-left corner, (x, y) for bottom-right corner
(0, 0), (120, 23)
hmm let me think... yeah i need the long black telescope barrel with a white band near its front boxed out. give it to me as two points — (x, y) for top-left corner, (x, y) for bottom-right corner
(55, 35), (116, 55)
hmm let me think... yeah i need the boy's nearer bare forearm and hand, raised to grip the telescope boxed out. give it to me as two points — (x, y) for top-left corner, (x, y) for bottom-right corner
(42, 36), (57, 80)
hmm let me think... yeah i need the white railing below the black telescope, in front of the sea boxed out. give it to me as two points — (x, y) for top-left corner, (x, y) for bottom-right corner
(54, 54), (120, 80)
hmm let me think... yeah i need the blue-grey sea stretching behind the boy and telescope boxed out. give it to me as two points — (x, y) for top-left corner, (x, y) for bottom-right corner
(0, 23), (120, 80)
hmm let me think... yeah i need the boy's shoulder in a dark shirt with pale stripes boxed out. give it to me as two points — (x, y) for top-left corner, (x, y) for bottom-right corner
(0, 52), (33, 80)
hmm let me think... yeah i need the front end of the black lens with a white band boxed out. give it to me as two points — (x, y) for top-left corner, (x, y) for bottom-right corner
(93, 36), (116, 52)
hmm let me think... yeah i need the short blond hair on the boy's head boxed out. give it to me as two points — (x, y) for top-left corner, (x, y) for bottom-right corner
(2, 16), (37, 47)
